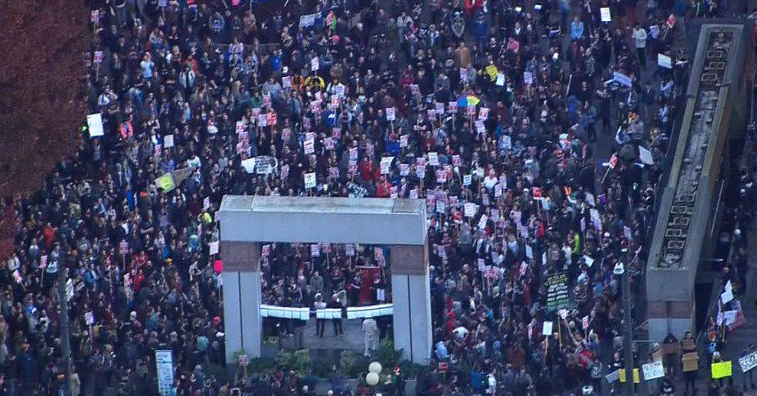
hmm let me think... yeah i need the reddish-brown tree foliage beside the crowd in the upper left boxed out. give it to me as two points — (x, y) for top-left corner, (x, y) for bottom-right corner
(0, 0), (88, 259)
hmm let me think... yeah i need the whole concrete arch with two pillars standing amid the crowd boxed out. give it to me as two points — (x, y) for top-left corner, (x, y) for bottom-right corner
(217, 195), (433, 364)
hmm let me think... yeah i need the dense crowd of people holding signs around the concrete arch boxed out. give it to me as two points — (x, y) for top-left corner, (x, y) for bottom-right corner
(0, 0), (752, 396)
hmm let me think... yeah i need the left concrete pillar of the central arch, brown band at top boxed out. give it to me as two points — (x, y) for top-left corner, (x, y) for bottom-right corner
(221, 241), (263, 363)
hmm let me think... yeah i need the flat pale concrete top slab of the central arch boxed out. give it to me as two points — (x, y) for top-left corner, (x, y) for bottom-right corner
(217, 195), (426, 245)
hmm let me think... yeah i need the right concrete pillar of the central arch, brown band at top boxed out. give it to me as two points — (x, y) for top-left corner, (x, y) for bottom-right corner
(390, 245), (433, 365)
